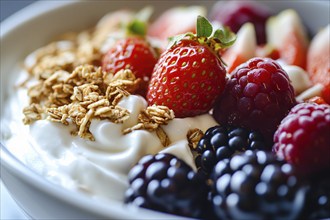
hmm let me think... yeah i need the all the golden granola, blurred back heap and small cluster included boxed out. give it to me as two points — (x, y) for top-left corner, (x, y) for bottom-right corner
(23, 18), (174, 143)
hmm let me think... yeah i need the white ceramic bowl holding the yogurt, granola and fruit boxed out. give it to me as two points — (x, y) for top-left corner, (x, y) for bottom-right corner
(0, 0), (329, 219)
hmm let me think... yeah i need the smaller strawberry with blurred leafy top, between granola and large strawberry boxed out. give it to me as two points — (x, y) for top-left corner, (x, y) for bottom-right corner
(102, 7), (159, 96)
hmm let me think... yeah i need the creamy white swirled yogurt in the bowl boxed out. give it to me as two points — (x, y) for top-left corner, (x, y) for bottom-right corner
(6, 75), (217, 201)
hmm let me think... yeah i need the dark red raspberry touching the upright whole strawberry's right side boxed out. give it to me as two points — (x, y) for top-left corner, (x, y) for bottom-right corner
(213, 58), (296, 141)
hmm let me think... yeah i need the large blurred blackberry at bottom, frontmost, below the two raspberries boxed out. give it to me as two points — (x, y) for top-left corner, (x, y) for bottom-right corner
(210, 150), (307, 219)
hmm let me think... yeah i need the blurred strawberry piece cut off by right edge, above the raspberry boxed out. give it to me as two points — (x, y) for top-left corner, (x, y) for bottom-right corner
(307, 25), (330, 103)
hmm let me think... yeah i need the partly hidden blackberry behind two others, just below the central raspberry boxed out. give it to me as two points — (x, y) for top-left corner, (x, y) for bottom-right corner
(195, 126), (271, 177)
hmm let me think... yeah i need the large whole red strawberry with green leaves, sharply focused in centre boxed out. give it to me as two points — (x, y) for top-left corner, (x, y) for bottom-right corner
(147, 16), (236, 118)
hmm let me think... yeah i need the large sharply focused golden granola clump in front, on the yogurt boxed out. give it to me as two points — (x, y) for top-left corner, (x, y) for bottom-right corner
(23, 64), (139, 140)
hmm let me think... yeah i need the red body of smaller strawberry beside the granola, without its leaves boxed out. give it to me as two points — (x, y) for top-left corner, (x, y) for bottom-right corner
(102, 37), (158, 96)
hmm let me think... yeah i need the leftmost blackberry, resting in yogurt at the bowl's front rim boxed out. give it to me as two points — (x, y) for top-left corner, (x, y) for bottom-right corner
(125, 154), (207, 218)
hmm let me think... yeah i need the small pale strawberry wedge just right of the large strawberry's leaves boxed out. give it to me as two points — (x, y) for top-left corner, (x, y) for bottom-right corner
(222, 23), (257, 73)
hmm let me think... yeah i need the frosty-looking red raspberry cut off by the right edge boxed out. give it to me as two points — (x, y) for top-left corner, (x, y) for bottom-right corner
(274, 103), (330, 174)
